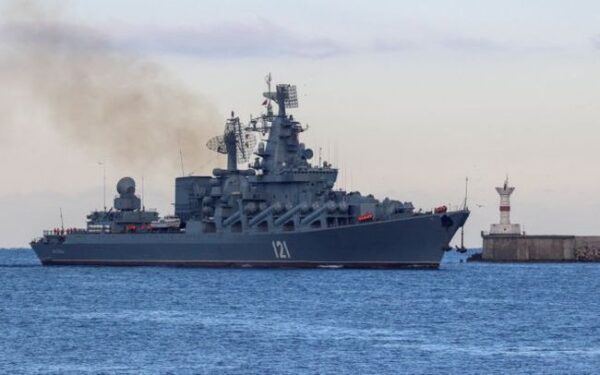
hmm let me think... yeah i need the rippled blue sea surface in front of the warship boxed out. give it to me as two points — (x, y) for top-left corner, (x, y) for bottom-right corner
(0, 250), (600, 374)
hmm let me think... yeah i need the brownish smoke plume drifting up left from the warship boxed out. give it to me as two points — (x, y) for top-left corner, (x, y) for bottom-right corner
(0, 1), (221, 167)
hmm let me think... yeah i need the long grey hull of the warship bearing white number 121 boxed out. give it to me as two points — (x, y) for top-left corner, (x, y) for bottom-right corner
(31, 210), (469, 268)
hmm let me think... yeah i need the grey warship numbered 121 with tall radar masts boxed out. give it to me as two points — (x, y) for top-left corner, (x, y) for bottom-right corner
(31, 75), (469, 268)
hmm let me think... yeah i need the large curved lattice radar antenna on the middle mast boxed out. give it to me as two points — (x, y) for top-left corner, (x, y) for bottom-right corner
(206, 112), (256, 171)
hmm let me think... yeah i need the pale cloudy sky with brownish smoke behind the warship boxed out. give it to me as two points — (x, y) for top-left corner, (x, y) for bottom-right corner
(0, 0), (600, 246)
